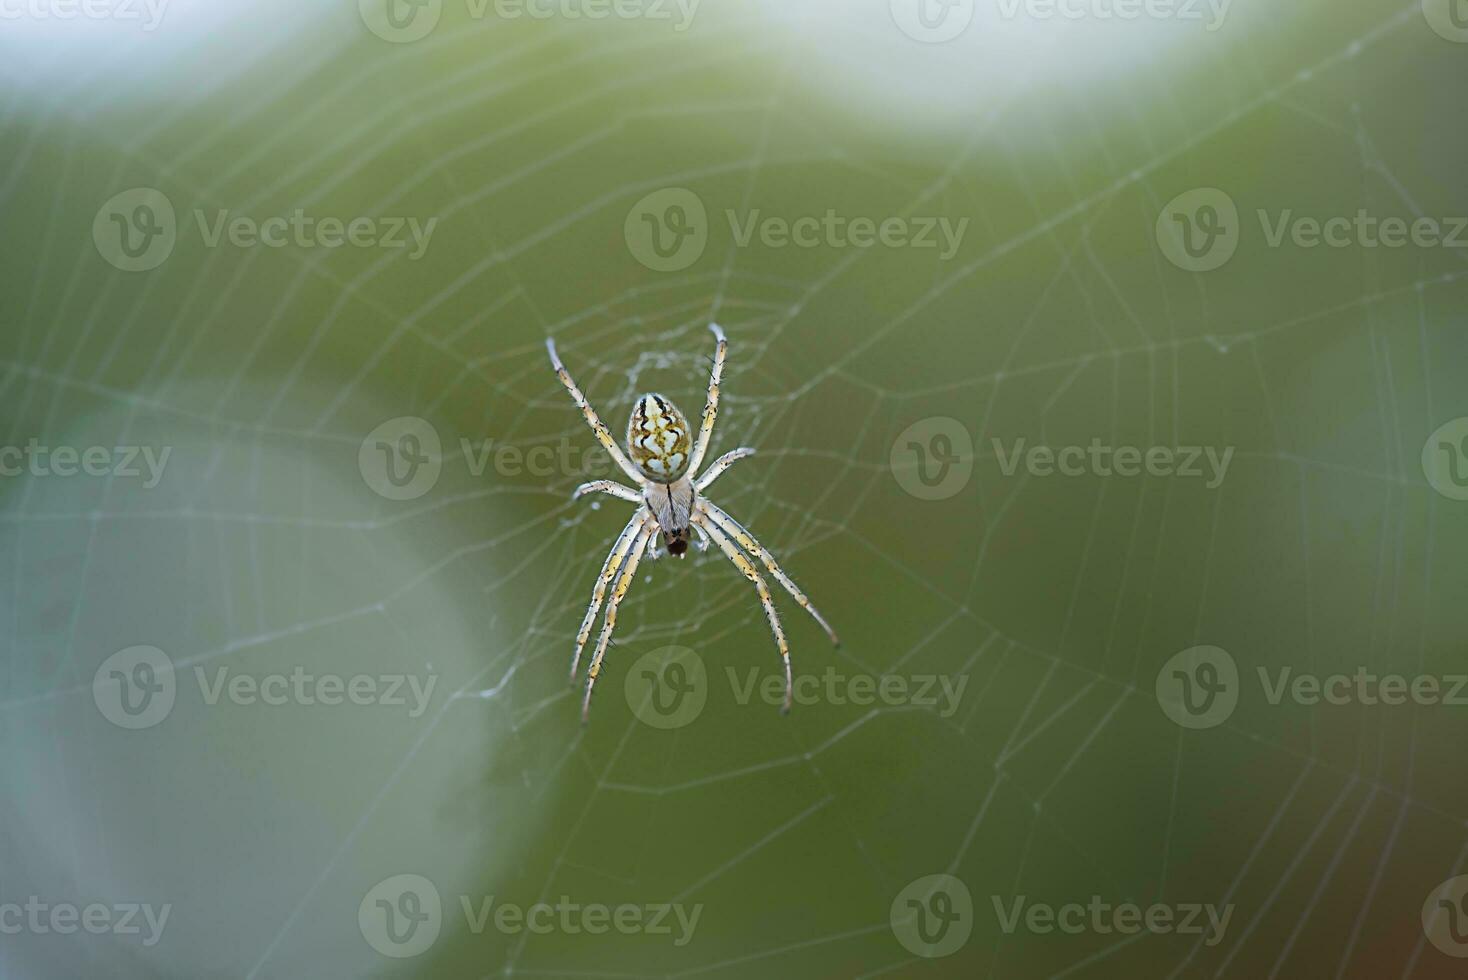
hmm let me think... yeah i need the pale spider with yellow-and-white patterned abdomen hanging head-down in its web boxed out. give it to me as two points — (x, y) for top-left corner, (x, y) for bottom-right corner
(546, 323), (840, 725)
